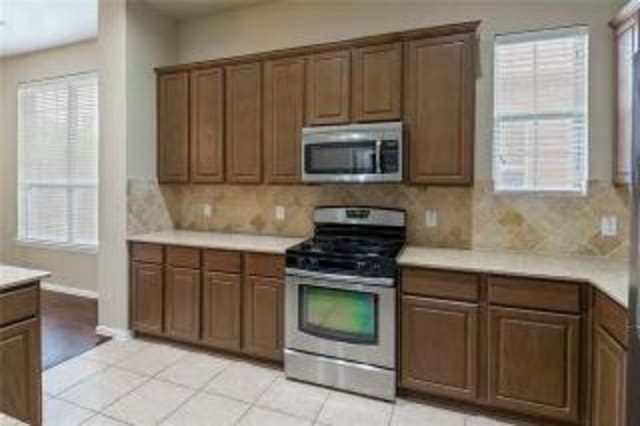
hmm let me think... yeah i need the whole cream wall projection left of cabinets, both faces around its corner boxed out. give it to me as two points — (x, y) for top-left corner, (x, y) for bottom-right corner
(98, 0), (177, 331)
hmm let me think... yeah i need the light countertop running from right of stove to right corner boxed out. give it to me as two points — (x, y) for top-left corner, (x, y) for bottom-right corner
(398, 246), (629, 307)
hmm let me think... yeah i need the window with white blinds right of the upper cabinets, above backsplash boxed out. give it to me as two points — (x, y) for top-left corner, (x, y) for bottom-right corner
(493, 27), (589, 193)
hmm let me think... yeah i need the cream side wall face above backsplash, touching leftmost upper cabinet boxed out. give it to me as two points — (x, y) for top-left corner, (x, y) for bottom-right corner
(127, 0), (178, 177)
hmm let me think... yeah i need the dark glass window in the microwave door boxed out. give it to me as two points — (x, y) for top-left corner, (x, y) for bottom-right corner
(305, 141), (376, 174)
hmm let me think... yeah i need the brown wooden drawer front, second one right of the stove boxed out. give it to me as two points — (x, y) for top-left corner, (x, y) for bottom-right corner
(488, 276), (580, 313)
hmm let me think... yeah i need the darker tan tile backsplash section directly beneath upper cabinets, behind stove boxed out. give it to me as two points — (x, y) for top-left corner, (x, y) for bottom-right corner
(162, 185), (472, 248)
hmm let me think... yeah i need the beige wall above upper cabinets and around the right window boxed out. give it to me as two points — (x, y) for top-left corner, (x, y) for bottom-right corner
(178, 0), (621, 180)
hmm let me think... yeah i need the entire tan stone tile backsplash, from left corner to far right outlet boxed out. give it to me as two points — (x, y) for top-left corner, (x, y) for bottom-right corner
(128, 178), (629, 259)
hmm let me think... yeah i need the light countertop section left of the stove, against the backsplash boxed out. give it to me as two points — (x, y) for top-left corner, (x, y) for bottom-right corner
(128, 230), (305, 254)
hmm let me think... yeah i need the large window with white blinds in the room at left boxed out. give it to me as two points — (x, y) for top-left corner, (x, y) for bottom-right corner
(18, 73), (98, 250)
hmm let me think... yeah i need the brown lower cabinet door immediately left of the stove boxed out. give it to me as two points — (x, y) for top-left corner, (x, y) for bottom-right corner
(244, 276), (284, 361)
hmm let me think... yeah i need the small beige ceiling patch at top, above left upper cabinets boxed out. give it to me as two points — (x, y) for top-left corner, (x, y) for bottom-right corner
(142, 0), (269, 20)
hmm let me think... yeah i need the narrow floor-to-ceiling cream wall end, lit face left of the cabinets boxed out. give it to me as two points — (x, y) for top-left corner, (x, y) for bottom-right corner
(98, 0), (129, 330)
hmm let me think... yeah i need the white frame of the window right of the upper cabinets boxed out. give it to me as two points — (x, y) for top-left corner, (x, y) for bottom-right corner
(491, 24), (591, 197)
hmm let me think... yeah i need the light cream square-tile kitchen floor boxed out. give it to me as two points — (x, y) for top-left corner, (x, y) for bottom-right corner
(32, 340), (524, 426)
